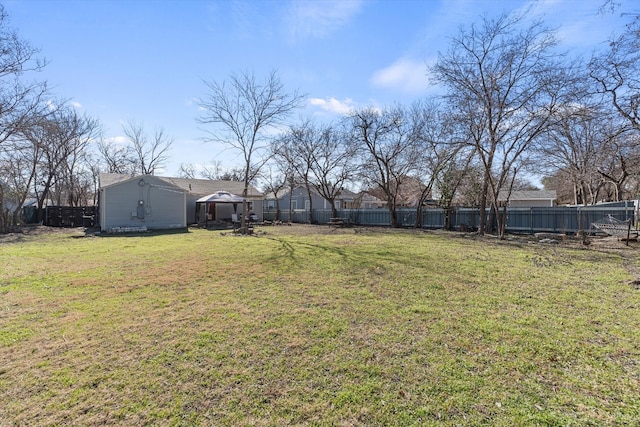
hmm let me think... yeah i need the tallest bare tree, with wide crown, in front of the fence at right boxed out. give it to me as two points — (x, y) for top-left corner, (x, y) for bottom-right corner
(431, 15), (562, 237)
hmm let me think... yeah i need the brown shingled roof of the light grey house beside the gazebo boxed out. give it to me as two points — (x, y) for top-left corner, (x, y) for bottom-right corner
(100, 173), (262, 198)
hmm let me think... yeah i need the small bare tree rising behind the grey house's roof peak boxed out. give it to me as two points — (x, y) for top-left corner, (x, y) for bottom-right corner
(122, 120), (173, 175)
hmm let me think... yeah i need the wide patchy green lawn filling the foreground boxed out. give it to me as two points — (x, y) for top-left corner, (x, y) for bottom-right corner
(0, 227), (640, 426)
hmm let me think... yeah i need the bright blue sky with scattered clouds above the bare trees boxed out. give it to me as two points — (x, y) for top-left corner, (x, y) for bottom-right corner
(3, 0), (638, 175)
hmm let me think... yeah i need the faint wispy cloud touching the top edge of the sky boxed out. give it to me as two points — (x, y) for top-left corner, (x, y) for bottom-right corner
(286, 0), (362, 41)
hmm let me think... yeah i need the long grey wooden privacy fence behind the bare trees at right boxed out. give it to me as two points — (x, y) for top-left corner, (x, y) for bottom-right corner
(264, 201), (636, 234)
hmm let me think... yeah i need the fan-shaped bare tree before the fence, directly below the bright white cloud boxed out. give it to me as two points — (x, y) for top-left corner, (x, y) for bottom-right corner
(348, 104), (424, 227)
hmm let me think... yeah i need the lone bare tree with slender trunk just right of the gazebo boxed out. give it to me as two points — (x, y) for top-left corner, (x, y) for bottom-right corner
(198, 71), (302, 232)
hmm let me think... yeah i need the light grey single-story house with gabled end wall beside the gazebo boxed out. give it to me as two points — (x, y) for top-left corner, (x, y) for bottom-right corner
(98, 173), (262, 230)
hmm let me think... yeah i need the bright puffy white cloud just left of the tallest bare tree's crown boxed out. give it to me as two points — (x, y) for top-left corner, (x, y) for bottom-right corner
(371, 58), (429, 93)
